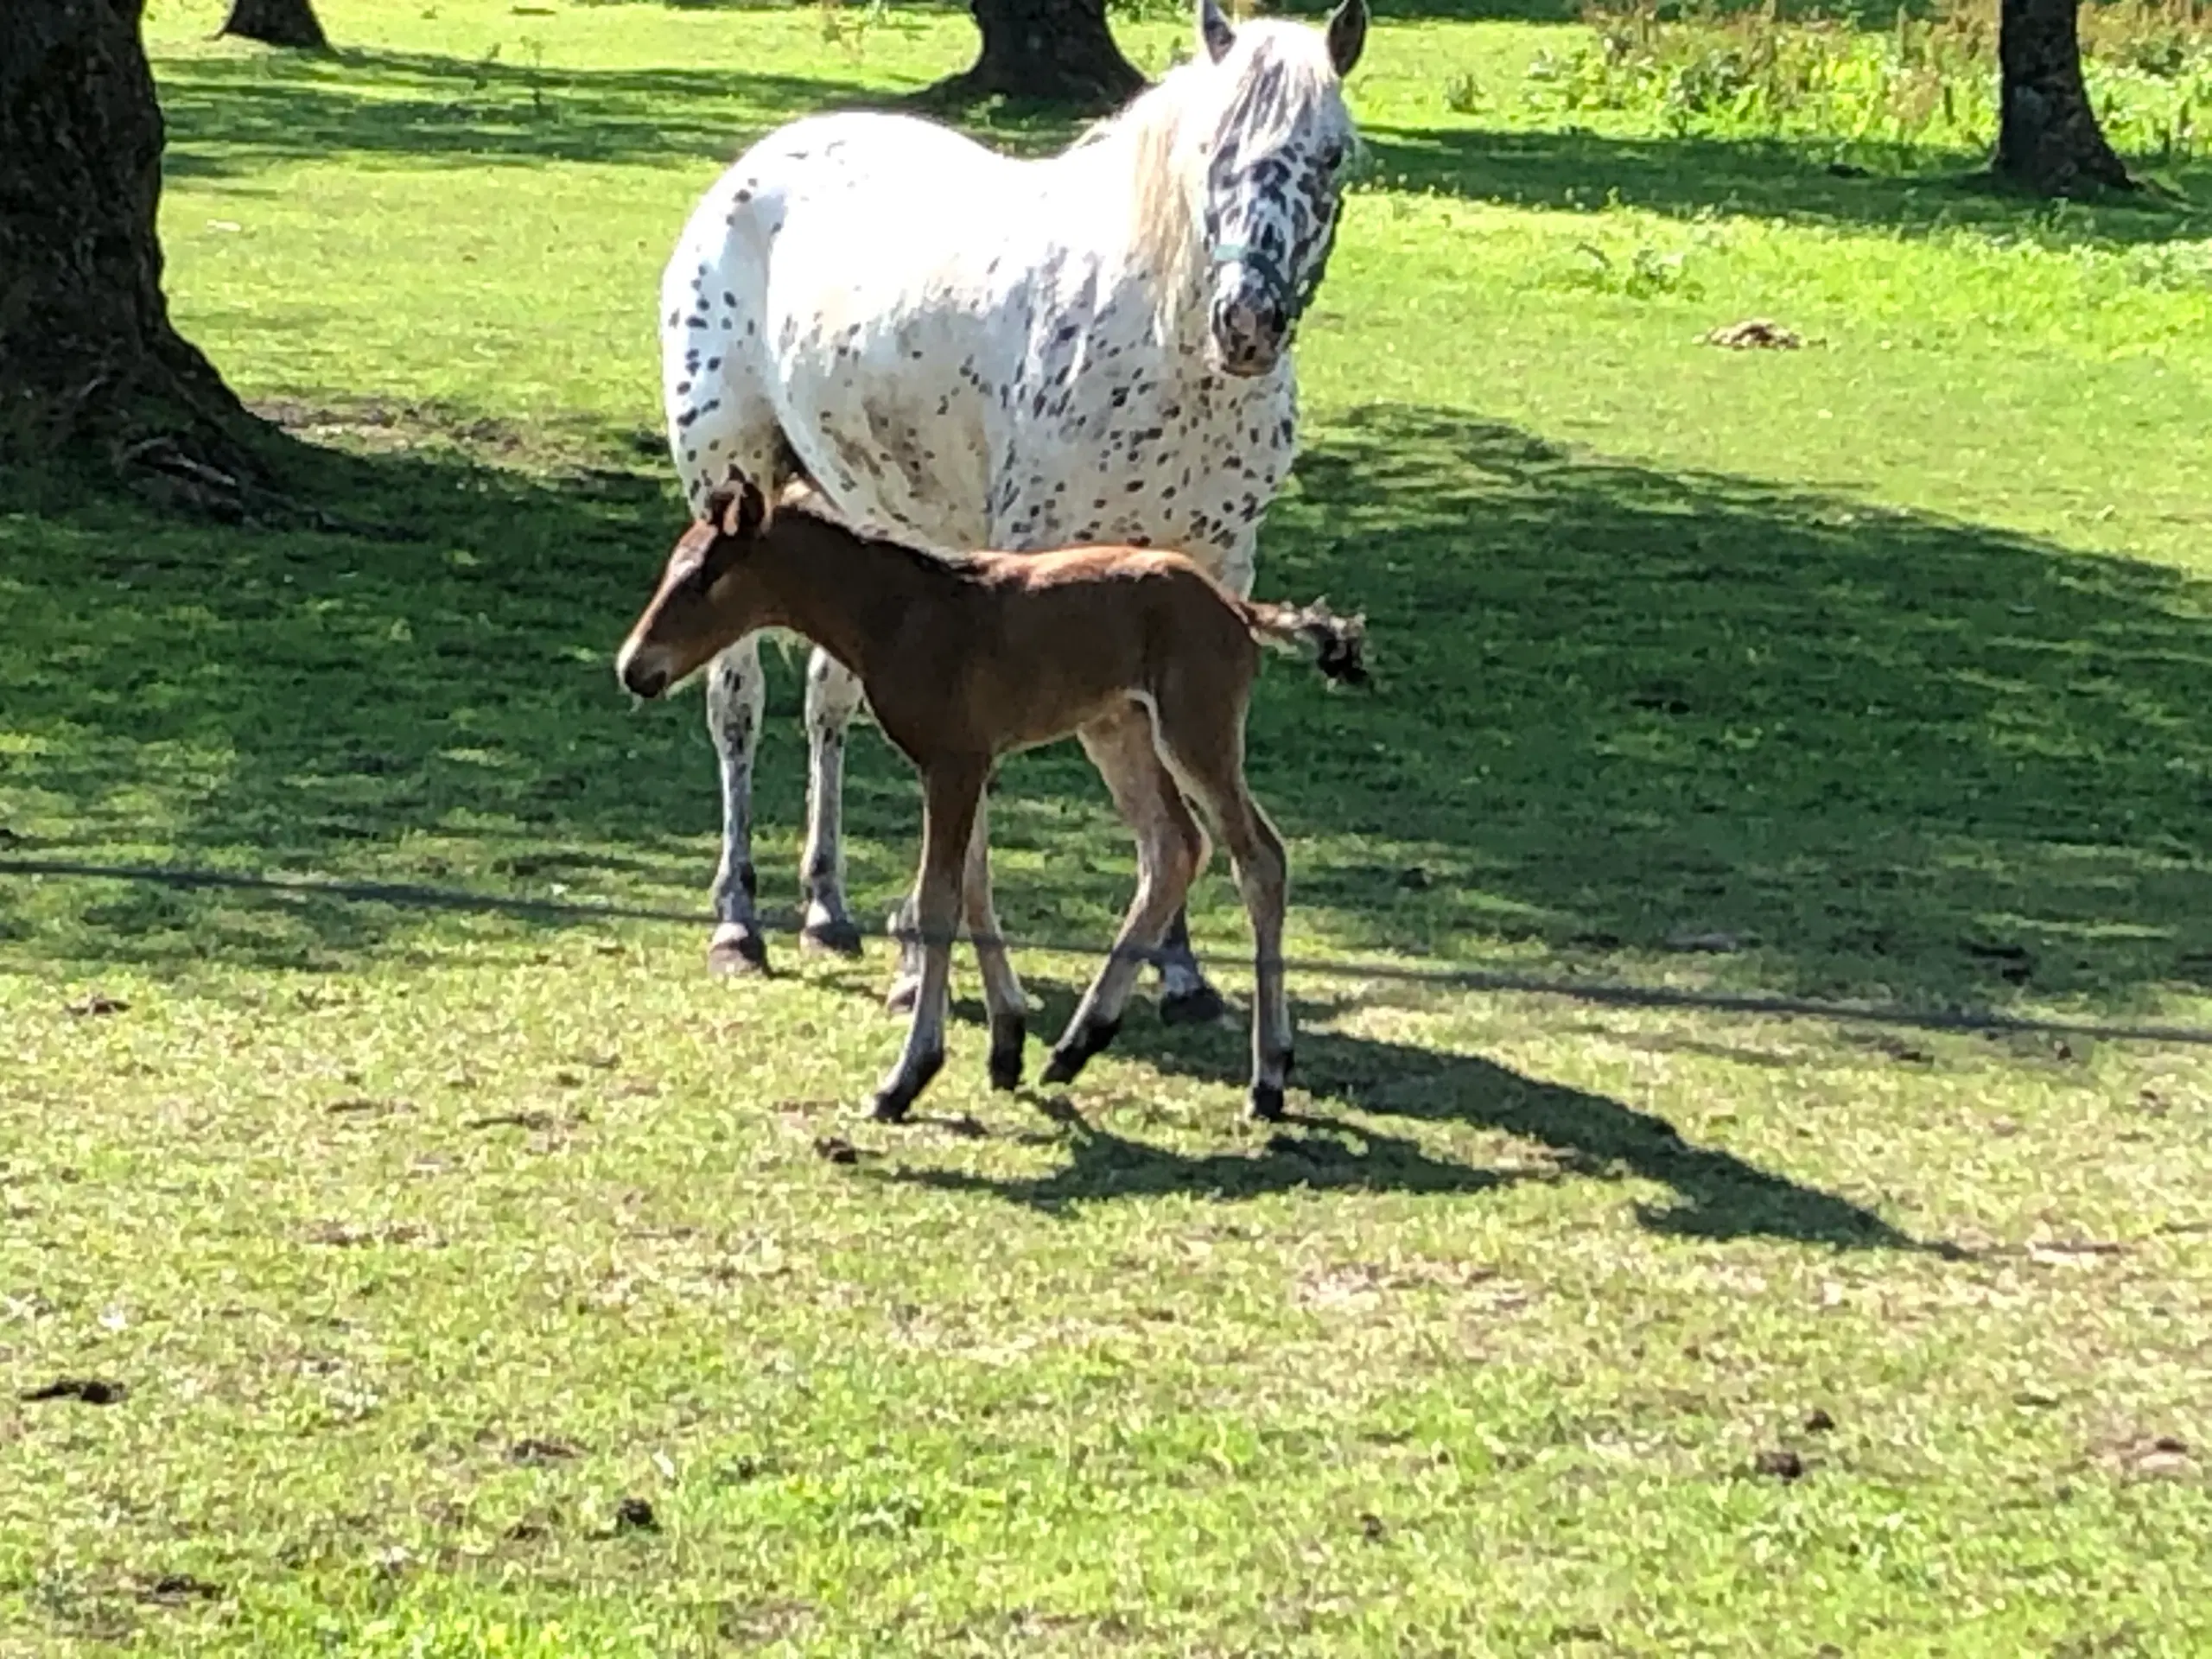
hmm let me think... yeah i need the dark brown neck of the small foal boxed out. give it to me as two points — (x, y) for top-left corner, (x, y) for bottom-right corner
(754, 511), (963, 681)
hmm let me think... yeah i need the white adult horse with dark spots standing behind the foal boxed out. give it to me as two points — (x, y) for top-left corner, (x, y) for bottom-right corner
(661, 0), (1367, 1020)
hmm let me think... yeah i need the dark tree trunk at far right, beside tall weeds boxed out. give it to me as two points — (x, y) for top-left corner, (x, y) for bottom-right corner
(1993, 0), (2134, 197)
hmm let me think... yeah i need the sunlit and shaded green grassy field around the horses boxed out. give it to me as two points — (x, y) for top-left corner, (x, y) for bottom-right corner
(0, 0), (2212, 1659)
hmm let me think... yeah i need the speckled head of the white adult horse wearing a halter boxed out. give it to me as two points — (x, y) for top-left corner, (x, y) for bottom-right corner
(1199, 0), (1367, 374)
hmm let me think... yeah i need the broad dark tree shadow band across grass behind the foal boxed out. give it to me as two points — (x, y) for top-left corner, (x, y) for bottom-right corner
(0, 410), (2212, 1015)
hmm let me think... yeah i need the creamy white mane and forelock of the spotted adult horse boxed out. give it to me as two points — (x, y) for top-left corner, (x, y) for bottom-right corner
(1077, 17), (1351, 339)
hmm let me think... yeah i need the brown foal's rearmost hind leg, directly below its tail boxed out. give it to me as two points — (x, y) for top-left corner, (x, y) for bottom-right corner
(1159, 699), (1292, 1119)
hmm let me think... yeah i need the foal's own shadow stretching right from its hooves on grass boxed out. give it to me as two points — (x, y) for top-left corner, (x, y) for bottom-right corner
(887, 987), (1958, 1256)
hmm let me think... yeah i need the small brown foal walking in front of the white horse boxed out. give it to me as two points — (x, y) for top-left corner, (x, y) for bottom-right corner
(615, 480), (1365, 1119)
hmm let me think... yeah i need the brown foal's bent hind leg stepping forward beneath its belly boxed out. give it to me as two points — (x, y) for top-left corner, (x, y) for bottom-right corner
(1042, 703), (1205, 1084)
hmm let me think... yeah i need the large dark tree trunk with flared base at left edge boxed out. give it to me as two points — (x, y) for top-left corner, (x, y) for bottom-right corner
(0, 0), (259, 511)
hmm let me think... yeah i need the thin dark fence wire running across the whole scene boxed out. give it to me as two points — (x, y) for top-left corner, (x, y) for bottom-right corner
(0, 858), (2212, 1048)
